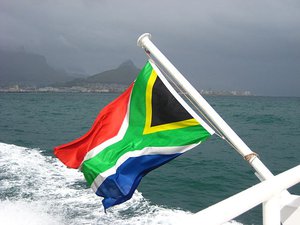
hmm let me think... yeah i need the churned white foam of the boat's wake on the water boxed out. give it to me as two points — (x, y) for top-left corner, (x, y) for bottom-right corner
(0, 143), (244, 225)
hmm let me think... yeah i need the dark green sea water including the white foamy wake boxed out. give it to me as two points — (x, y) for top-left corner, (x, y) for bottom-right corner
(0, 93), (300, 225)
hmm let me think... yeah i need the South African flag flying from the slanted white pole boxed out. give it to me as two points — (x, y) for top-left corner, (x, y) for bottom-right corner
(54, 61), (214, 209)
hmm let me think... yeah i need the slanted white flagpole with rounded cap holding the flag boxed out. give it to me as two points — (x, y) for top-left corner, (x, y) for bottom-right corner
(137, 33), (274, 180)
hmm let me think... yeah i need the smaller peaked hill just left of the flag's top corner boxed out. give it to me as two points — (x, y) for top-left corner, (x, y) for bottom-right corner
(59, 60), (140, 87)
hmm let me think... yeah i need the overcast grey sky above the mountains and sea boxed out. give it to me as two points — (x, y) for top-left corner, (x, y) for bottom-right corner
(0, 0), (300, 96)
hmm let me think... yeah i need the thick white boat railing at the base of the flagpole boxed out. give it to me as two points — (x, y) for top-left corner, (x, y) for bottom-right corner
(186, 165), (300, 225)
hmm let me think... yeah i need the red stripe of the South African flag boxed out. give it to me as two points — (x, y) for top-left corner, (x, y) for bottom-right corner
(54, 84), (133, 168)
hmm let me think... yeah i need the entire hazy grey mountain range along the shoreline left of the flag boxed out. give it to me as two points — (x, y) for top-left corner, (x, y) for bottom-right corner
(0, 49), (139, 87)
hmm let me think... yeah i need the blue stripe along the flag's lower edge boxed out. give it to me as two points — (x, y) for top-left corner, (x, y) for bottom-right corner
(96, 153), (181, 209)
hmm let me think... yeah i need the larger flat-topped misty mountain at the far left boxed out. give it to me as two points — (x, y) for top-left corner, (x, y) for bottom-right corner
(0, 50), (73, 86)
